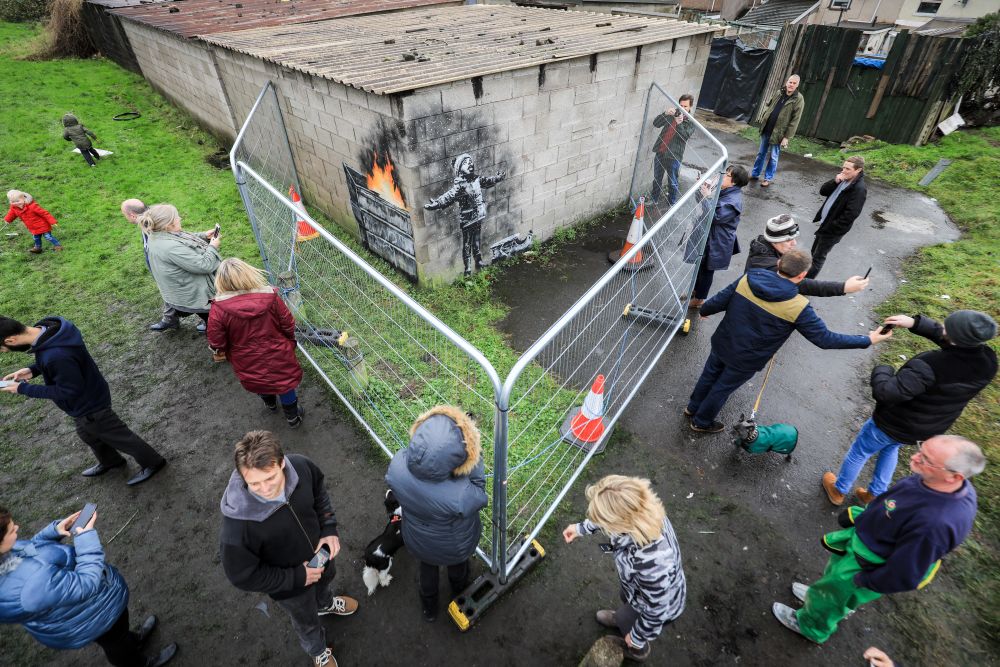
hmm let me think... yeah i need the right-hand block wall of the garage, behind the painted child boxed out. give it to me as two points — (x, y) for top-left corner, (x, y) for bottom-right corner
(397, 35), (710, 279)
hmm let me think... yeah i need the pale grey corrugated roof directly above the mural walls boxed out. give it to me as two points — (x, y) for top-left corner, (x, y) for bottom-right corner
(202, 5), (721, 94)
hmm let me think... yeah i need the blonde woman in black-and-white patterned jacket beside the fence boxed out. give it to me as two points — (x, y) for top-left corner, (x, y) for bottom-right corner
(563, 475), (687, 662)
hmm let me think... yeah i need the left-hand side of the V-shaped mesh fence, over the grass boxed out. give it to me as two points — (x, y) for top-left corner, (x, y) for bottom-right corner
(233, 84), (499, 563)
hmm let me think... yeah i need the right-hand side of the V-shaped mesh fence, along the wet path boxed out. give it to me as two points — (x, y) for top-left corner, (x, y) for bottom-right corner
(494, 85), (726, 563)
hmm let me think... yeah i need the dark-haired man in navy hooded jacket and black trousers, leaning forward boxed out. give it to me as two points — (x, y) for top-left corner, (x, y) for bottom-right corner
(0, 317), (167, 486)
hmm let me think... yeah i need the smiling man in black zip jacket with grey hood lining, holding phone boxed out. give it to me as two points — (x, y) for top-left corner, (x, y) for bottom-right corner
(221, 431), (358, 667)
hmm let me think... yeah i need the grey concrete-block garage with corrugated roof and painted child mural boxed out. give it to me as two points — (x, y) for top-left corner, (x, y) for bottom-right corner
(116, 0), (719, 281)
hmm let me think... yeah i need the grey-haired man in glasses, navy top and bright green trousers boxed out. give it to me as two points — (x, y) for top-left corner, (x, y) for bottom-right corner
(771, 435), (986, 644)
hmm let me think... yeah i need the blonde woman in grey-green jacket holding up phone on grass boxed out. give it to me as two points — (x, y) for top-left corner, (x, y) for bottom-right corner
(139, 204), (222, 332)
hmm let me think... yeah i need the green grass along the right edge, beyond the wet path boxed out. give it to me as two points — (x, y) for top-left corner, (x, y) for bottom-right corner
(741, 127), (1000, 646)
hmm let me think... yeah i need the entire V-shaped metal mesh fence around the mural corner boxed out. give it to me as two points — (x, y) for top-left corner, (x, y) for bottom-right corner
(230, 83), (727, 604)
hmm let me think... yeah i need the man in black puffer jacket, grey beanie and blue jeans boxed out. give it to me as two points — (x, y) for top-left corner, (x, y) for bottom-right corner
(823, 310), (997, 505)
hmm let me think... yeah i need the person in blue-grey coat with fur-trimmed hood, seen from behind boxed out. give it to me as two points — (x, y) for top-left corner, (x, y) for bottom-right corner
(385, 405), (489, 623)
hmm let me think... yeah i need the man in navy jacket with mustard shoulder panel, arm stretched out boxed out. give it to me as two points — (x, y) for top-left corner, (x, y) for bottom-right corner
(684, 250), (892, 433)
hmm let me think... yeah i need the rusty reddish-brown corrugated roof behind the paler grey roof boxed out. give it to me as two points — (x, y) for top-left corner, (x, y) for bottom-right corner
(112, 0), (461, 37)
